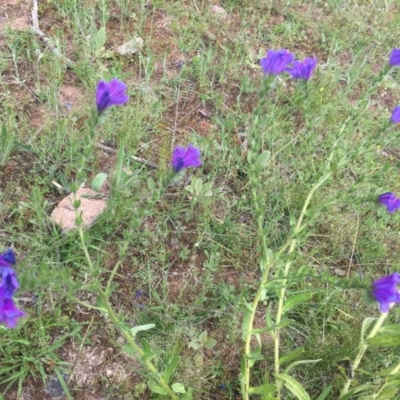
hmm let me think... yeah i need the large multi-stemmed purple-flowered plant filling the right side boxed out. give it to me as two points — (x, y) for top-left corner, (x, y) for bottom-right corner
(240, 49), (400, 400)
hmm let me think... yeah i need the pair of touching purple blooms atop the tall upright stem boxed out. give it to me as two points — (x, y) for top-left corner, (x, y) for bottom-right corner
(260, 49), (318, 81)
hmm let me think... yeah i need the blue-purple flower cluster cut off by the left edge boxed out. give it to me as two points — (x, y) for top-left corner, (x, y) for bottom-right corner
(0, 249), (26, 328)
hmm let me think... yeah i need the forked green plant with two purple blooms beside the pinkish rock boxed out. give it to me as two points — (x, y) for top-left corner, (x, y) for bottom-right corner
(68, 79), (202, 400)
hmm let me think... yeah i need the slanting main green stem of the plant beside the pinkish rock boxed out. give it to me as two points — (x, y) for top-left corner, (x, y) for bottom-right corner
(79, 225), (179, 400)
